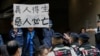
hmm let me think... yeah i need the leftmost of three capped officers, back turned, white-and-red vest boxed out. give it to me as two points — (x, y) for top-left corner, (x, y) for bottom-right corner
(48, 33), (77, 56)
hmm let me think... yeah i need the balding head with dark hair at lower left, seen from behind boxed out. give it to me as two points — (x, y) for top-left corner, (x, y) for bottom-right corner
(7, 40), (19, 55)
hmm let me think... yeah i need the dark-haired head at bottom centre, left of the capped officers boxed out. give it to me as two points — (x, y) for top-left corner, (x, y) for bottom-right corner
(36, 45), (49, 56)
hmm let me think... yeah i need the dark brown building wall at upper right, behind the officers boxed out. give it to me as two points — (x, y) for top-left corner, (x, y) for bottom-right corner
(69, 0), (100, 44)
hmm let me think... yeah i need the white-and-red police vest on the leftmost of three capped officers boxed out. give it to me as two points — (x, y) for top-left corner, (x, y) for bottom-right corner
(48, 34), (77, 56)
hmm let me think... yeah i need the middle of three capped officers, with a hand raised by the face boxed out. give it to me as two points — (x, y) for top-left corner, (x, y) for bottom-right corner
(64, 32), (80, 56)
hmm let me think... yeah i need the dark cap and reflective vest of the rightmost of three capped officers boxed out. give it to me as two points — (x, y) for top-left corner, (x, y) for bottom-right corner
(79, 34), (100, 56)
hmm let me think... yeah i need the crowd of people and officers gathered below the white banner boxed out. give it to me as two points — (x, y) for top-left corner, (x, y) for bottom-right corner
(0, 21), (100, 56)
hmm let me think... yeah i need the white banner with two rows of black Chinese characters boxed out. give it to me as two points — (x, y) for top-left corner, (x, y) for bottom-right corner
(13, 4), (49, 28)
